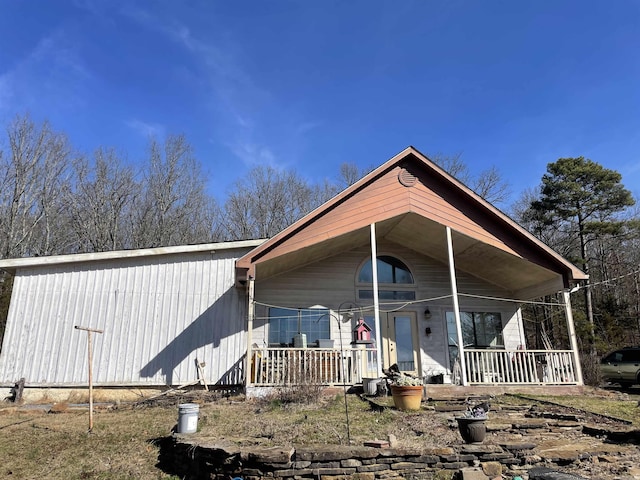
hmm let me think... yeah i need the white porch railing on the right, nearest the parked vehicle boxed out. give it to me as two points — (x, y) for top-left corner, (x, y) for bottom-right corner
(464, 349), (577, 385)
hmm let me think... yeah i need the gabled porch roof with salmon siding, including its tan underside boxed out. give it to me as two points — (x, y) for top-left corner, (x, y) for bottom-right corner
(236, 147), (587, 298)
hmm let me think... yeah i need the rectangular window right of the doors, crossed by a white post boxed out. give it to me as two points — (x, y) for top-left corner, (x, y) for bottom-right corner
(447, 312), (504, 362)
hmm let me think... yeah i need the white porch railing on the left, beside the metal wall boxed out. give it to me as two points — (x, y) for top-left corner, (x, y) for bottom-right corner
(250, 348), (376, 386)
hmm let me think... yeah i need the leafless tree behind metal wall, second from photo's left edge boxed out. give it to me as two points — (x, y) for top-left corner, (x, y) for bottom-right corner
(66, 148), (139, 252)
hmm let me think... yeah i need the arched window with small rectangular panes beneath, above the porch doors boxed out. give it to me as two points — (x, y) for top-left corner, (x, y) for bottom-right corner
(358, 255), (416, 301)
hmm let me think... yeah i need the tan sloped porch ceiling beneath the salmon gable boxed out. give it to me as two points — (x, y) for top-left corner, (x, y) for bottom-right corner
(256, 213), (563, 299)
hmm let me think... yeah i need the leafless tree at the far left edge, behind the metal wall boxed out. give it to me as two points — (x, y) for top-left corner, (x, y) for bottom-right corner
(0, 115), (71, 257)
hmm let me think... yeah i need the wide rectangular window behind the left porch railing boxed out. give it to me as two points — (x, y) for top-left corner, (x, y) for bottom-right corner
(269, 307), (331, 347)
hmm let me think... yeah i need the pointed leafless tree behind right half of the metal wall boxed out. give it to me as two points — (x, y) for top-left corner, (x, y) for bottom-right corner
(130, 135), (216, 248)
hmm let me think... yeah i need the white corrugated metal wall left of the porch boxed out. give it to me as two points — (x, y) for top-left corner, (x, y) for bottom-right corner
(0, 249), (249, 386)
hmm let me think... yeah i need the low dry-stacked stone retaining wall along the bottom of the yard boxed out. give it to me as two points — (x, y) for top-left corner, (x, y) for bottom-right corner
(161, 435), (541, 480)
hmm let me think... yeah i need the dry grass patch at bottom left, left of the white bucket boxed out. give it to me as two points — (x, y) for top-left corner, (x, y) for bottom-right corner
(0, 408), (177, 480)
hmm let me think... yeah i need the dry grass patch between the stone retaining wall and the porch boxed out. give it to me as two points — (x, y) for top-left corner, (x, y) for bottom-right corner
(200, 395), (458, 446)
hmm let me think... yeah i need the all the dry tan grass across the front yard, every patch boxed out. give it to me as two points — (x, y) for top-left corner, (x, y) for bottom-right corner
(0, 388), (640, 480)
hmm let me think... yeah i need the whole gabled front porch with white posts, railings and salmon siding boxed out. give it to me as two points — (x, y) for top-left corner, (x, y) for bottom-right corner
(236, 148), (587, 387)
